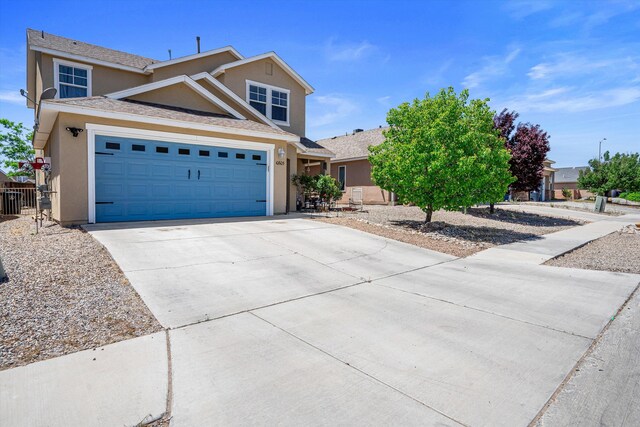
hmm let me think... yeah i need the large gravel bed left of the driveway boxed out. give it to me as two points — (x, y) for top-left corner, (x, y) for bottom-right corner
(0, 217), (162, 370)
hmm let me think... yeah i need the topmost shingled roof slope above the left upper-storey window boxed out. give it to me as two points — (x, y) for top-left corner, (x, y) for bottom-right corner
(27, 28), (159, 72)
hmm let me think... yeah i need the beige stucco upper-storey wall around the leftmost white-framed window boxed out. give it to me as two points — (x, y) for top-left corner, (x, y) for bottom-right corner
(38, 53), (151, 96)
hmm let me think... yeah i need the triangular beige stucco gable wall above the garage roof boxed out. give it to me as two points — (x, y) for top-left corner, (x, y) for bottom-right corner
(128, 83), (229, 115)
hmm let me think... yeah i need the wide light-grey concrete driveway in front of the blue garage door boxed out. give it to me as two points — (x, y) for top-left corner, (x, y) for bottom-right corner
(0, 218), (640, 426)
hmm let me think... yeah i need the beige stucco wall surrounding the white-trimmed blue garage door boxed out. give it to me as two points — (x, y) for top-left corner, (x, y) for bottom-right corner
(45, 113), (295, 225)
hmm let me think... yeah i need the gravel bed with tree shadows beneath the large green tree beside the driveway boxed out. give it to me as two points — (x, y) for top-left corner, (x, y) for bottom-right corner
(314, 205), (585, 257)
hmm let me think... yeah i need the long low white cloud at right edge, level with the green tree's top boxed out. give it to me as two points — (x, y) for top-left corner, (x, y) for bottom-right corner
(504, 86), (640, 113)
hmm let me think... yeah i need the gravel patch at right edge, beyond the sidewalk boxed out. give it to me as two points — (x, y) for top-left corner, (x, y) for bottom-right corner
(545, 225), (640, 274)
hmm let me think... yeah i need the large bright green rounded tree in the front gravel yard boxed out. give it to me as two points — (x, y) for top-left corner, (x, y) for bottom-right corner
(369, 88), (514, 222)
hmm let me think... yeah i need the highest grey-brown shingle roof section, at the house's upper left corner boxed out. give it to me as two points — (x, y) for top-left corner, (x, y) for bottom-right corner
(27, 29), (160, 70)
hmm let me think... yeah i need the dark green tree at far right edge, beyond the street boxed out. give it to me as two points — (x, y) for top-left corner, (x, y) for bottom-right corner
(578, 151), (640, 196)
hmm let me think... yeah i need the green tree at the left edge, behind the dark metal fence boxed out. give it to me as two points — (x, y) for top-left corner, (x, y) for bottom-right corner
(0, 119), (35, 176)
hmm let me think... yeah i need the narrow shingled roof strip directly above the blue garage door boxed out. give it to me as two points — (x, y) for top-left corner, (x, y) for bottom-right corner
(43, 96), (297, 138)
